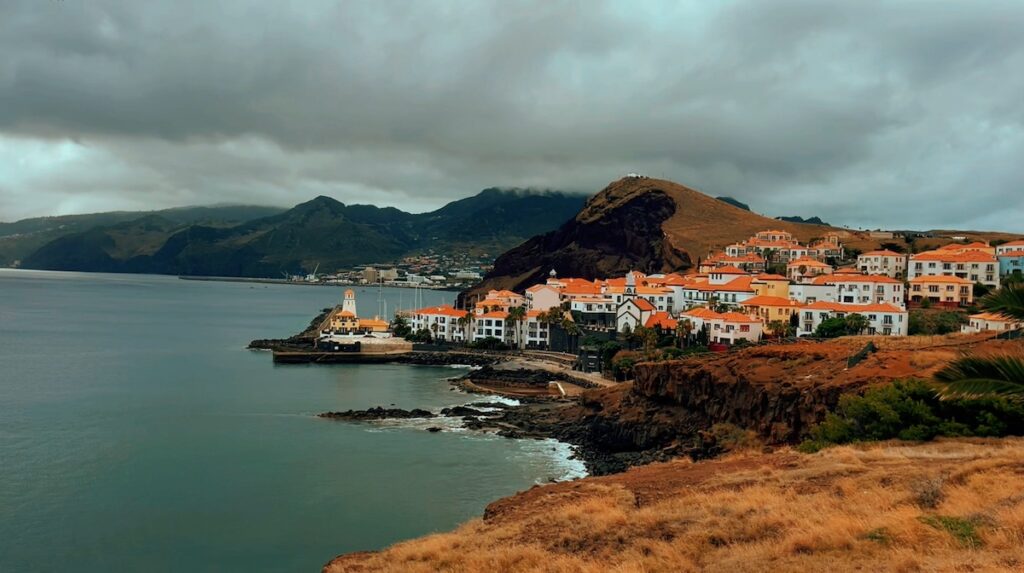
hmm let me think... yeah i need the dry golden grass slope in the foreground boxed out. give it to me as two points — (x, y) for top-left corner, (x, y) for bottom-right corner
(325, 439), (1024, 573)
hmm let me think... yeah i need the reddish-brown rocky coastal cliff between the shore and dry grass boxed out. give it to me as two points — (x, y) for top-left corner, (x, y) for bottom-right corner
(498, 337), (995, 475)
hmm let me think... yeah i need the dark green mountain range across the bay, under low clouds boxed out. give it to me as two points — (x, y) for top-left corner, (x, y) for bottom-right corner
(8, 188), (586, 277)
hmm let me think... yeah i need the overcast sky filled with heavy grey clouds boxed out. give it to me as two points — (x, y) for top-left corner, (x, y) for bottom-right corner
(0, 0), (1024, 232)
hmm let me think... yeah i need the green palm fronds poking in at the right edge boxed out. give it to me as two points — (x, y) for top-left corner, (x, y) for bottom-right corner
(935, 284), (1024, 400)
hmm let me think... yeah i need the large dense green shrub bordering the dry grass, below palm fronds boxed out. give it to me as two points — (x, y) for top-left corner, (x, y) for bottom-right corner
(800, 380), (1024, 452)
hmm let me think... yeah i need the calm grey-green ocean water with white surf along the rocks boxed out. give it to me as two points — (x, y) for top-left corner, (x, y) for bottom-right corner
(0, 270), (582, 572)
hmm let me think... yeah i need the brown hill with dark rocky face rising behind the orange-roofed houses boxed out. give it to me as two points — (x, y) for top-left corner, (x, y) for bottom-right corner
(469, 177), (854, 297)
